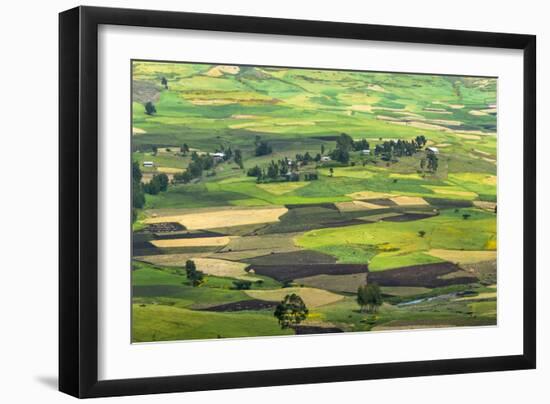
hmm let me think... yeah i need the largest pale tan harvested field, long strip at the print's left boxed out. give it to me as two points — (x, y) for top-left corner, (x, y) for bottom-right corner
(145, 207), (288, 230)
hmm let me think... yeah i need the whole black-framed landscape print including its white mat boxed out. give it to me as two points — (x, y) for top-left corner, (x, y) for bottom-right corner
(59, 7), (536, 397)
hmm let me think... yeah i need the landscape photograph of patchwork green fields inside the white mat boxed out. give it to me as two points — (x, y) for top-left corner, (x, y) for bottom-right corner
(132, 61), (497, 342)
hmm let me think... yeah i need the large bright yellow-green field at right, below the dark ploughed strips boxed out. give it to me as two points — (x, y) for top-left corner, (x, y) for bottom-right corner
(295, 209), (496, 271)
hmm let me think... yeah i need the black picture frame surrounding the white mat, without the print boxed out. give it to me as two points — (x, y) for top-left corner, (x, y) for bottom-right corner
(59, 7), (536, 398)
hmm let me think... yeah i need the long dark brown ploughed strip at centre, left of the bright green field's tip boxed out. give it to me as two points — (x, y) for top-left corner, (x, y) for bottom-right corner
(252, 264), (368, 281)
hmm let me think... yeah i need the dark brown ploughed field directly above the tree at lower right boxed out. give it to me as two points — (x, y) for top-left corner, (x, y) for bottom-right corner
(368, 262), (478, 288)
